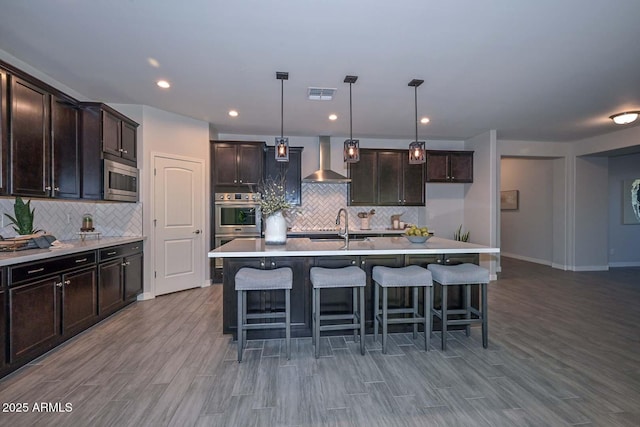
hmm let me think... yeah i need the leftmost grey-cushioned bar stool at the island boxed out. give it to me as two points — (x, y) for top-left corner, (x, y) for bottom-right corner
(235, 267), (293, 362)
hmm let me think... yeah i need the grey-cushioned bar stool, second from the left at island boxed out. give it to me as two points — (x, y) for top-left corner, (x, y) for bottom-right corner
(311, 265), (367, 359)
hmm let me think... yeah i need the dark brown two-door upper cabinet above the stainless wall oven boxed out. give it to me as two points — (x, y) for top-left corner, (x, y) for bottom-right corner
(212, 141), (265, 187)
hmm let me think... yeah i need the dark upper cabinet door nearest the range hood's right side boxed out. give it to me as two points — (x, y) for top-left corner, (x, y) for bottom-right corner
(348, 150), (378, 206)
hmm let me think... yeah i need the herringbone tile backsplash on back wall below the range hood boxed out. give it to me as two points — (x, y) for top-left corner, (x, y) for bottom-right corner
(287, 182), (425, 230)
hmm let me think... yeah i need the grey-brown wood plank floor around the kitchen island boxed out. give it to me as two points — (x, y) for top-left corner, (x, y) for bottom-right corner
(0, 258), (640, 427)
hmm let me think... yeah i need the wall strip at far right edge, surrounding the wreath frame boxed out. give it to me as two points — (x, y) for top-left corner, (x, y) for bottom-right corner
(609, 154), (640, 267)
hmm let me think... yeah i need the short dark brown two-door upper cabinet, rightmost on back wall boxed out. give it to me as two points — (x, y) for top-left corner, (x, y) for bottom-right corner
(427, 150), (473, 183)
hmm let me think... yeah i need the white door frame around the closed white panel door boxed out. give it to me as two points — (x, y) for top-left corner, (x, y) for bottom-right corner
(147, 151), (206, 298)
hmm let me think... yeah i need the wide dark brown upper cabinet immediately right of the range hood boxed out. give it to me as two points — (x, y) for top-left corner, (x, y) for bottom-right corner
(349, 149), (425, 206)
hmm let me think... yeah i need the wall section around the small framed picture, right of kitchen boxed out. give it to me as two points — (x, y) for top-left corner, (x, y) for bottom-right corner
(500, 158), (555, 265)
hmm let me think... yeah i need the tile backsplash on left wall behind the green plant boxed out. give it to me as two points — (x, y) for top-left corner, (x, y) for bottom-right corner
(0, 198), (142, 240)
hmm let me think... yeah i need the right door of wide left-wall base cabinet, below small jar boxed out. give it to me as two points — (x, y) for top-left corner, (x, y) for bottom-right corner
(62, 266), (98, 335)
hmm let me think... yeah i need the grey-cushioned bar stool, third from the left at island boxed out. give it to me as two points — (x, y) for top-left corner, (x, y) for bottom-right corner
(371, 265), (433, 354)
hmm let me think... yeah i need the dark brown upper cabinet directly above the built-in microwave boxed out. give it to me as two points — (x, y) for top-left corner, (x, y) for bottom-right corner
(81, 102), (138, 167)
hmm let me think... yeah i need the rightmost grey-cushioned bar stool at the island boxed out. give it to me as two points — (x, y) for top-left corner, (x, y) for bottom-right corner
(427, 263), (489, 351)
